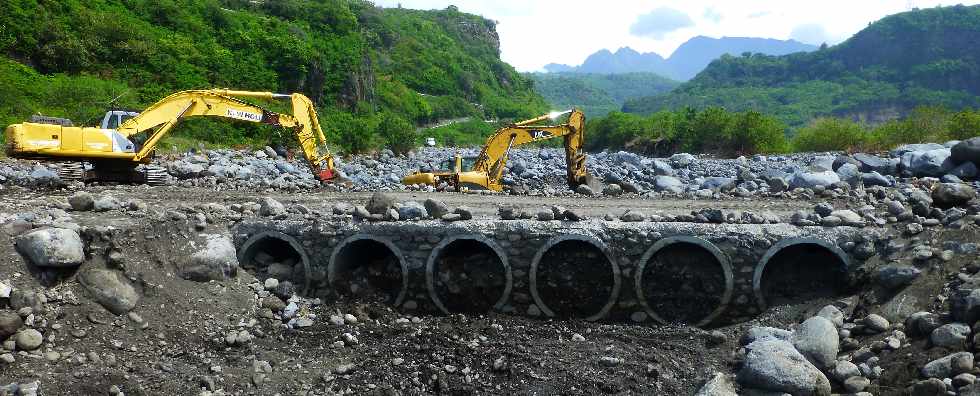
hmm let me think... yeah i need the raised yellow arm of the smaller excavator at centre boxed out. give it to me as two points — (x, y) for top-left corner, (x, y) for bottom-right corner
(459, 110), (592, 190)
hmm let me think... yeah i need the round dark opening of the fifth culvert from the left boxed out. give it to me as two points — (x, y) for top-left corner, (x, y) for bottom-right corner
(639, 242), (728, 324)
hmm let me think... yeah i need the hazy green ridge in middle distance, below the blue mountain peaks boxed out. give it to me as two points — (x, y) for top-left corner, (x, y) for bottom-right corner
(529, 73), (680, 117)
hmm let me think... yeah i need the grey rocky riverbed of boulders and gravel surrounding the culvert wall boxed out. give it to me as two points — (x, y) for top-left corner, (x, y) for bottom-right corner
(0, 139), (980, 395)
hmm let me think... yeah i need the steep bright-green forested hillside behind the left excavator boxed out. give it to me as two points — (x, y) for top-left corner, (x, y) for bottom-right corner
(0, 0), (548, 152)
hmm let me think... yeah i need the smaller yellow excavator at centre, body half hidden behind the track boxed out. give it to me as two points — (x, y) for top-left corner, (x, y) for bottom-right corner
(402, 109), (596, 191)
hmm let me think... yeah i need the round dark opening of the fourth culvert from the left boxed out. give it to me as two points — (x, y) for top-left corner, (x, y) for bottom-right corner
(536, 240), (616, 318)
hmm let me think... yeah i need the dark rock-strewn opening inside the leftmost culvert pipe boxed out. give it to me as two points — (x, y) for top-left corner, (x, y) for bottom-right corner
(239, 236), (306, 288)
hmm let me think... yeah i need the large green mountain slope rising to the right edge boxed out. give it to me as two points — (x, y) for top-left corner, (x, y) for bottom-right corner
(623, 6), (980, 126)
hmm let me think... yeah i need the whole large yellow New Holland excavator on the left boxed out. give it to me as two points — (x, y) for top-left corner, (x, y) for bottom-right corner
(5, 89), (336, 184)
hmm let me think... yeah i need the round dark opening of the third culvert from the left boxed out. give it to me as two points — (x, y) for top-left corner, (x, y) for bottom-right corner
(432, 239), (507, 314)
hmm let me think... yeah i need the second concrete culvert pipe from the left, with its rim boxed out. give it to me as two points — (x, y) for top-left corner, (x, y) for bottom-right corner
(327, 235), (408, 305)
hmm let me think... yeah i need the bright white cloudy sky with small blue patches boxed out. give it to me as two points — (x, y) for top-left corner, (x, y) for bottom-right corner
(374, 0), (980, 71)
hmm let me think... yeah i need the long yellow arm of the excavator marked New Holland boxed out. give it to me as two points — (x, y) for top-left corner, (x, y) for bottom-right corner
(118, 89), (335, 181)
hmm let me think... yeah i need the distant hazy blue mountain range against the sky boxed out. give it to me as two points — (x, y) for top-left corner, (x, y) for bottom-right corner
(544, 36), (817, 81)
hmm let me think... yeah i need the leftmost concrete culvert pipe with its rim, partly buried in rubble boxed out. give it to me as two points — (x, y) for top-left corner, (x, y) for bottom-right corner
(238, 231), (310, 293)
